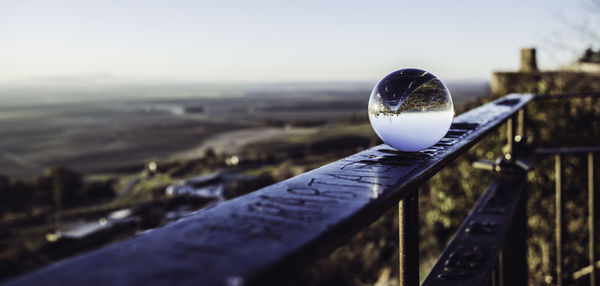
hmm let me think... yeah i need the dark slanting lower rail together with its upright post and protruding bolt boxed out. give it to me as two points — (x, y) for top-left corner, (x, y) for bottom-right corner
(422, 98), (533, 286)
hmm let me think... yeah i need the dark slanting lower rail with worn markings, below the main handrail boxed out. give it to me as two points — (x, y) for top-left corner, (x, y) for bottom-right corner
(422, 171), (527, 286)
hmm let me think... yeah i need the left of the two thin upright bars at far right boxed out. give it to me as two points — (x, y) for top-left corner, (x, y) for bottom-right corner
(554, 154), (563, 286)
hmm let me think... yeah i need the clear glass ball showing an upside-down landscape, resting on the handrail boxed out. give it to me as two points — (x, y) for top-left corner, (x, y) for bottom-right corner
(369, 69), (454, 152)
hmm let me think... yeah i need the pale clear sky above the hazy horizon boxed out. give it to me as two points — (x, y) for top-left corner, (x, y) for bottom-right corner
(0, 0), (600, 84)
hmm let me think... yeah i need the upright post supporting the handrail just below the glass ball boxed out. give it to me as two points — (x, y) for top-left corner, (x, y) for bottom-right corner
(398, 188), (419, 286)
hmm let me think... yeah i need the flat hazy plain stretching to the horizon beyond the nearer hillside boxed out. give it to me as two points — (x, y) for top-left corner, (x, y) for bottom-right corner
(0, 82), (488, 177)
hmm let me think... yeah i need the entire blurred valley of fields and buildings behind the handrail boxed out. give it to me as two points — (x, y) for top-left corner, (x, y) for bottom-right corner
(0, 80), (487, 280)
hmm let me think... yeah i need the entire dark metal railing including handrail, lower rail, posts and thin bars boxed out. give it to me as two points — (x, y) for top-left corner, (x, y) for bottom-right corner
(7, 94), (600, 286)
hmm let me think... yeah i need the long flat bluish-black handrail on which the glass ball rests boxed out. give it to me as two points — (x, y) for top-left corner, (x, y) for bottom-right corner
(3, 94), (533, 285)
